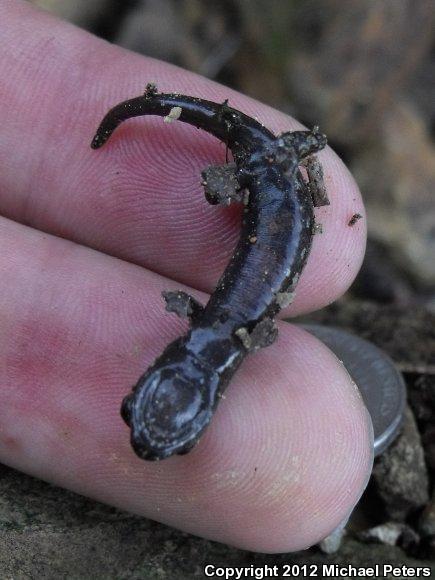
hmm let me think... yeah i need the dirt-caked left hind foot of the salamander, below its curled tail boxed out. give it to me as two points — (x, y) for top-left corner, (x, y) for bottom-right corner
(201, 163), (244, 205)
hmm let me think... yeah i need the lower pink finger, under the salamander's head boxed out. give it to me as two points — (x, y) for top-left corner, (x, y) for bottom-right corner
(0, 219), (373, 552)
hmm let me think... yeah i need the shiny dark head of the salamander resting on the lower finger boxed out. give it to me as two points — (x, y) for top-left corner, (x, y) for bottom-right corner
(121, 351), (219, 460)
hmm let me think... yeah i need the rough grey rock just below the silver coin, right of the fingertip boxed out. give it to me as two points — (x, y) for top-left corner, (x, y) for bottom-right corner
(373, 408), (429, 521)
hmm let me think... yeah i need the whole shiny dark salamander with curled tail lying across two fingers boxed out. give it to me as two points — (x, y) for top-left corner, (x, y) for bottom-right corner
(92, 85), (328, 460)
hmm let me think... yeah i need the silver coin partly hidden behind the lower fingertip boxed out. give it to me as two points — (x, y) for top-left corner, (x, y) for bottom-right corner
(302, 324), (406, 455)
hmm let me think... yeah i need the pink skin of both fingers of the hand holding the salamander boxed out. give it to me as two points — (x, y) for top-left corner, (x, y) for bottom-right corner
(0, 1), (372, 552)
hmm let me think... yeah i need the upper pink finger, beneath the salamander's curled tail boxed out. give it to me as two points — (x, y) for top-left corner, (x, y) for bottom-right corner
(0, 2), (365, 314)
